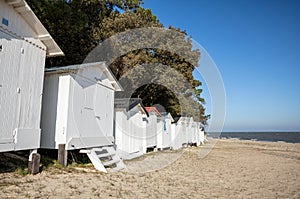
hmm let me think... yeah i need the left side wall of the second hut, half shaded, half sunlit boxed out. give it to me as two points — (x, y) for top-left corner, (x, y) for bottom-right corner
(41, 74), (71, 149)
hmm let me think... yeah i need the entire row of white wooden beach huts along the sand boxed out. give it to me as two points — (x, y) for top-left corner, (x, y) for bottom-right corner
(0, 0), (204, 172)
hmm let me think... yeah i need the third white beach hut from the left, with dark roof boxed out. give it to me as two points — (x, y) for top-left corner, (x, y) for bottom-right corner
(115, 98), (149, 159)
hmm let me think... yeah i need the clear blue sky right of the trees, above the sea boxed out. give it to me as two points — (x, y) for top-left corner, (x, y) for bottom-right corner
(143, 0), (300, 131)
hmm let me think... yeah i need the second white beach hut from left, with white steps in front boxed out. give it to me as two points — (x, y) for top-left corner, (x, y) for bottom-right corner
(41, 62), (122, 171)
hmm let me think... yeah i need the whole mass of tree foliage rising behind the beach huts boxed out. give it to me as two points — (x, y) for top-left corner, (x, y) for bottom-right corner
(27, 0), (209, 124)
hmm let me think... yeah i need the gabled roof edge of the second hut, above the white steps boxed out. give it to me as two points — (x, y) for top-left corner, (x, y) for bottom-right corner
(45, 62), (123, 91)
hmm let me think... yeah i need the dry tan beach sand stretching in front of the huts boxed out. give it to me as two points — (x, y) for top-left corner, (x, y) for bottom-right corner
(0, 140), (300, 198)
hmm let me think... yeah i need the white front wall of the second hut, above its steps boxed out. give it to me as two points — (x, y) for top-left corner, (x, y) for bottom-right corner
(67, 73), (114, 139)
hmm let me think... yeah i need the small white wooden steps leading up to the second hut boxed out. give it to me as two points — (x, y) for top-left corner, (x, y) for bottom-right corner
(80, 146), (126, 173)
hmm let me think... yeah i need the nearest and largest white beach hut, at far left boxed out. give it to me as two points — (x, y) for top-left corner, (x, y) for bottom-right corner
(0, 0), (63, 161)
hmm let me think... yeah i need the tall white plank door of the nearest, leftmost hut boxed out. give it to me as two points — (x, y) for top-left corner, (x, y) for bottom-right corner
(0, 36), (22, 145)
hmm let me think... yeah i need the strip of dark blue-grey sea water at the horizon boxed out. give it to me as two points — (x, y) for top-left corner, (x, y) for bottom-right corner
(207, 132), (300, 143)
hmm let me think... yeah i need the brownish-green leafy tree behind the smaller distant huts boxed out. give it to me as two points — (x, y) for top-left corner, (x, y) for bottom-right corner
(99, 8), (209, 124)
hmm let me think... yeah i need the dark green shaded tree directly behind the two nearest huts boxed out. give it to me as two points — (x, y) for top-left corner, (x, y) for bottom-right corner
(27, 0), (140, 67)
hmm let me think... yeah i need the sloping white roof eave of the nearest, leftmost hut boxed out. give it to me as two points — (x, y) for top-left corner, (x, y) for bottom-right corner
(6, 0), (64, 57)
